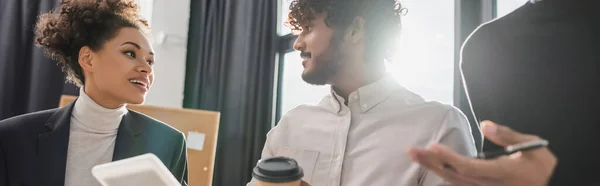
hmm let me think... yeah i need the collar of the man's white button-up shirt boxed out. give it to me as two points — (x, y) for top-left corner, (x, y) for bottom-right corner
(331, 75), (400, 113)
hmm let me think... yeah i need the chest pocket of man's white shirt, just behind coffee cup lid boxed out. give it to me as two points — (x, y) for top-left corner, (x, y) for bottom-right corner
(277, 147), (319, 184)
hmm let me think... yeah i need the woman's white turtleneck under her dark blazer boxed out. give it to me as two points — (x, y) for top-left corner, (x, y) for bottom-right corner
(65, 88), (127, 186)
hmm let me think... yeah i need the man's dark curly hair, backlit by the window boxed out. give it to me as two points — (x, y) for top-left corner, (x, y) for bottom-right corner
(286, 0), (404, 61)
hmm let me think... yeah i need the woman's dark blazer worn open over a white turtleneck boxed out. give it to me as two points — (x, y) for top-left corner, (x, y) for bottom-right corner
(0, 102), (187, 186)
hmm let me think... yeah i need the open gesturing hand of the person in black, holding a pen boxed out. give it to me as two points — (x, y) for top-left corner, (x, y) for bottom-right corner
(408, 121), (557, 186)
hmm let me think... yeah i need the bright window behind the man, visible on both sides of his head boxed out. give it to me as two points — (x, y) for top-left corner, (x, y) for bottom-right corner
(276, 0), (455, 119)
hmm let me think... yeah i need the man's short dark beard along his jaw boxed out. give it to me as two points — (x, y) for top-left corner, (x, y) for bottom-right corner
(302, 36), (342, 85)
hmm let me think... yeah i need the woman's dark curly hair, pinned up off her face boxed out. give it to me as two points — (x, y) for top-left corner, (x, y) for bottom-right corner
(35, 0), (150, 87)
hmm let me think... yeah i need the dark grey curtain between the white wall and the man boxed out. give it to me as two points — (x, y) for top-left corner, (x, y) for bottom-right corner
(184, 0), (277, 186)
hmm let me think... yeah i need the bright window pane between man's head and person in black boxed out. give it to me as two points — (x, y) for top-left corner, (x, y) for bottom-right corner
(388, 0), (454, 105)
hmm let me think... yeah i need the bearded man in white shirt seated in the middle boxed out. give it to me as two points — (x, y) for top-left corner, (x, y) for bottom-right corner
(249, 0), (476, 186)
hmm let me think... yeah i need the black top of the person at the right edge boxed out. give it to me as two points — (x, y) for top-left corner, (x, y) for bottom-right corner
(462, 0), (600, 186)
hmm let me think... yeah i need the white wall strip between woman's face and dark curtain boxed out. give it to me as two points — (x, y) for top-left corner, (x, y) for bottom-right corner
(138, 0), (190, 108)
